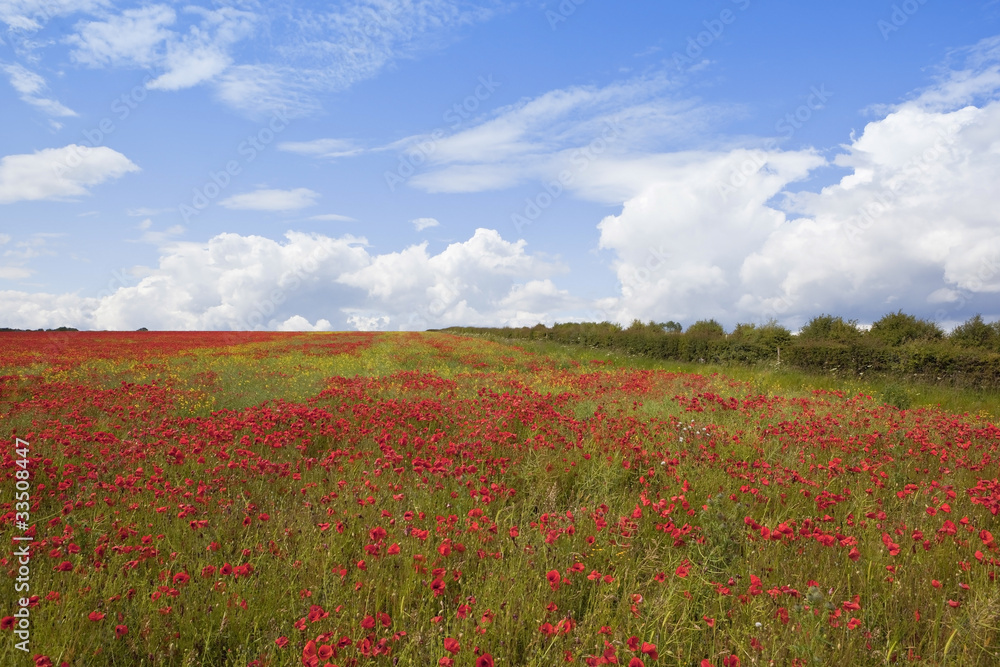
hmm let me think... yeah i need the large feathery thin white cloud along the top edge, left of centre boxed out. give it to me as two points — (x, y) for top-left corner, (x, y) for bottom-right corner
(53, 0), (504, 117)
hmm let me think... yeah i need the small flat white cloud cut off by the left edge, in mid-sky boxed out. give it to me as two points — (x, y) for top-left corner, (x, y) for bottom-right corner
(0, 144), (139, 204)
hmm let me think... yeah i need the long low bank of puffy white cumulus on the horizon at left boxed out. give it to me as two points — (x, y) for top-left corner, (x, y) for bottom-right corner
(0, 226), (578, 331)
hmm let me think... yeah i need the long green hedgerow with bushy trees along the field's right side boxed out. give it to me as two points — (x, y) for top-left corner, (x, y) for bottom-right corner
(444, 311), (1000, 388)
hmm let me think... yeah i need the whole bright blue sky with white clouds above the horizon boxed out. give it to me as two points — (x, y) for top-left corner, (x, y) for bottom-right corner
(0, 0), (1000, 330)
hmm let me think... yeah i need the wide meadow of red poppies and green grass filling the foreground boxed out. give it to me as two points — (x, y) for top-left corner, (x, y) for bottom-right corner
(0, 332), (1000, 667)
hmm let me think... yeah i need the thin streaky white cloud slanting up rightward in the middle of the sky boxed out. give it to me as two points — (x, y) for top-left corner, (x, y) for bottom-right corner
(397, 76), (733, 198)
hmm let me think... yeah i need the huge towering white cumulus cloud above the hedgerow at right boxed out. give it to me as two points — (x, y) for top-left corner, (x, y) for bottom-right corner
(599, 36), (1000, 327)
